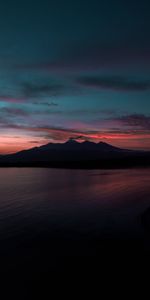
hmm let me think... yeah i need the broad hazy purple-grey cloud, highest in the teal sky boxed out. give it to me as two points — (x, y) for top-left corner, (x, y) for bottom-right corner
(14, 41), (150, 73)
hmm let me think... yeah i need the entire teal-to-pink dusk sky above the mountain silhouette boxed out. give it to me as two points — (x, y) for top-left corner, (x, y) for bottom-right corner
(0, 0), (150, 154)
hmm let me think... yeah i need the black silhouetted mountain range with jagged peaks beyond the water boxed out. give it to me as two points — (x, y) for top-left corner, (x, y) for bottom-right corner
(0, 139), (150, 168)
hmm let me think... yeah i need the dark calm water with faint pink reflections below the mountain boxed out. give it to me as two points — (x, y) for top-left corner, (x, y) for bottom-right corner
(0, 168), (150, 292)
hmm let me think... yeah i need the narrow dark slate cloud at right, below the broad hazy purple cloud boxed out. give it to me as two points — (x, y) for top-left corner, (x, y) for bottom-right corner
(76, 76), (150, 92)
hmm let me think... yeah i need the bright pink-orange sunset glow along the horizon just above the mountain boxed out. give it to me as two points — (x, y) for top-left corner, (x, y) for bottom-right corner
(0, 128), (150, 154)
